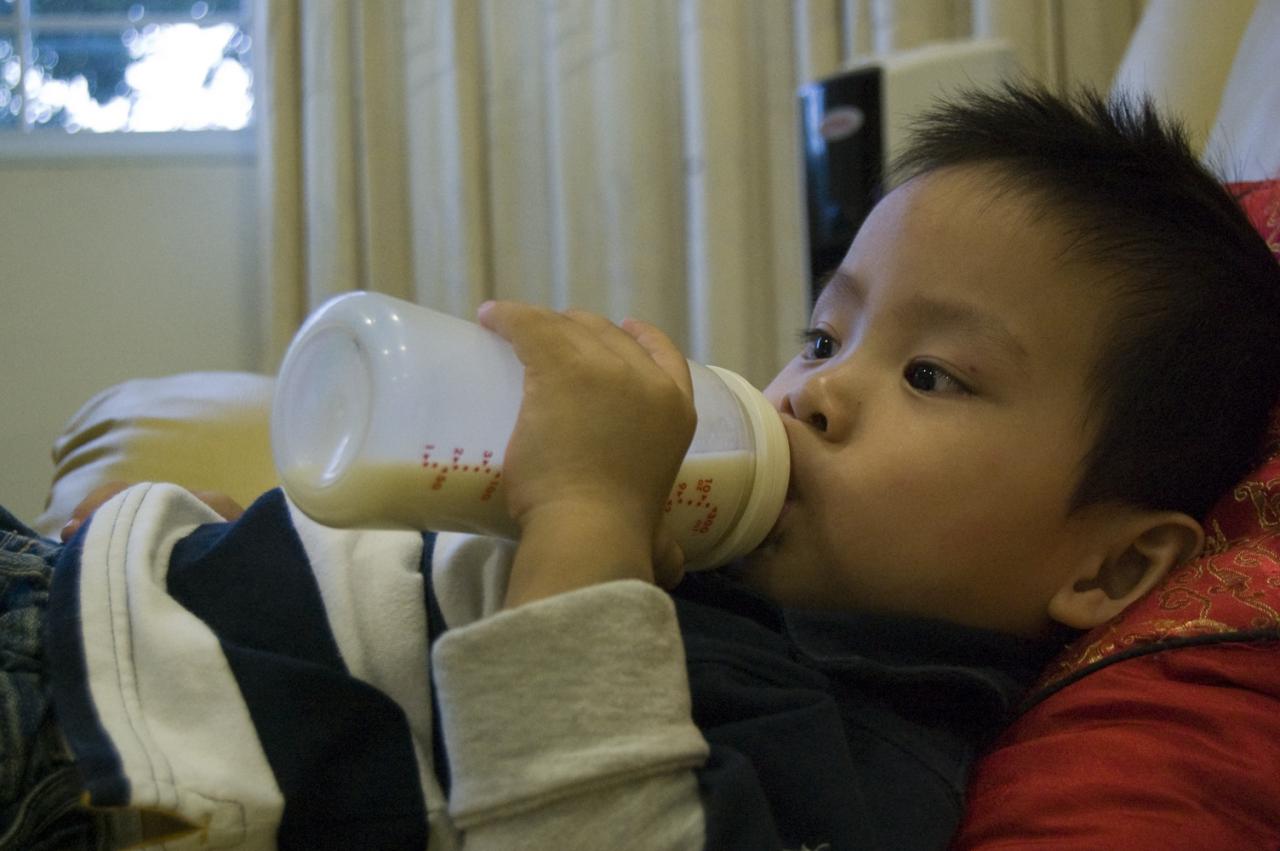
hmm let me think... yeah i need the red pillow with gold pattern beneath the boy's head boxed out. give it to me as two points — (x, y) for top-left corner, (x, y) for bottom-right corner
(954, 180), (1280, 851)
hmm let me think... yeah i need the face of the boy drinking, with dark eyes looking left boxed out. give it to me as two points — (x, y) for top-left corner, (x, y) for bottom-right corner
(740, 169), (1106, 635)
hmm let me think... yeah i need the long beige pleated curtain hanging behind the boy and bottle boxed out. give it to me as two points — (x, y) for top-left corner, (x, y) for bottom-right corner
(259, 0), (1140, 383)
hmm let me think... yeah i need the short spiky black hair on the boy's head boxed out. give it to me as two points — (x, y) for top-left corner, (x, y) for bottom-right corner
(892, 84), (1280, 518)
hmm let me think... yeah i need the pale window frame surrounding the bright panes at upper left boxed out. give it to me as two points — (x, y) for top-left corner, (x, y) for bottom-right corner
(0, 0), (262, 165)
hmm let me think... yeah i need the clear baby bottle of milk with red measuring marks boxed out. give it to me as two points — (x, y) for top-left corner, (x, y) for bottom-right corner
(271, 292), (790, 569)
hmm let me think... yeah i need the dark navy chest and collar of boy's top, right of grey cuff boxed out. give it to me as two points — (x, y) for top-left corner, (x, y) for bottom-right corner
(675, 573), (1060, 851)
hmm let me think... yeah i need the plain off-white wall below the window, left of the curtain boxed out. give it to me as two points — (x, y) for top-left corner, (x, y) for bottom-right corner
(0, 157), (261, 522)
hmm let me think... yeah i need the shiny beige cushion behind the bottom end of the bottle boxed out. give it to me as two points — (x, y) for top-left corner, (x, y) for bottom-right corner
(35, 372), (276, 535)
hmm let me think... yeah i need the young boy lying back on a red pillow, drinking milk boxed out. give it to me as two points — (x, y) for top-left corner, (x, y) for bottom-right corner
(0, 90), (1280, 851)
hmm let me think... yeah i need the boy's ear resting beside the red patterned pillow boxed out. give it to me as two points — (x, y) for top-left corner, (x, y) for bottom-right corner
(1048, 509), (1204, 630)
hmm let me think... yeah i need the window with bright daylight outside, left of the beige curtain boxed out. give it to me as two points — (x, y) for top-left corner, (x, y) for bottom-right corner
(0, 0), (253, 150)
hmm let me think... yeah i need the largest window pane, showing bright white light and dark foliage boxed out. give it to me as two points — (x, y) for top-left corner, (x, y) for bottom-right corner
(27, 23), (253, 132)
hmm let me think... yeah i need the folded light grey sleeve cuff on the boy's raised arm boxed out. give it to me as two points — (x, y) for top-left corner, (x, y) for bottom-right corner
(433, 581), (708, 851)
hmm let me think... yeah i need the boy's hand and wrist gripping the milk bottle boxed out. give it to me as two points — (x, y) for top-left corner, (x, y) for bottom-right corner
(480, 302), (696, 607)
